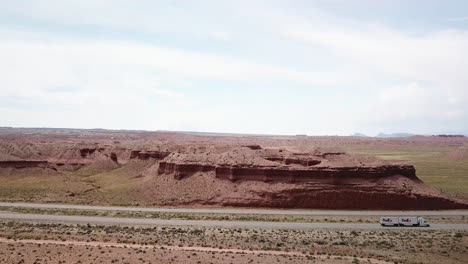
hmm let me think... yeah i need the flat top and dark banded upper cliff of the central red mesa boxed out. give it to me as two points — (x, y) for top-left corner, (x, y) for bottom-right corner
(158, 147), (419, 182)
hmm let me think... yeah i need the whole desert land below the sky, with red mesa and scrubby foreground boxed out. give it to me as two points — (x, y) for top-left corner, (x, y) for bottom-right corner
(0, 128), (468, 263)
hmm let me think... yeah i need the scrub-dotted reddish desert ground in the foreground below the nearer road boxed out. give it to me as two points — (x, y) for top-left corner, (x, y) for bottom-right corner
(0, 221), (468, 264)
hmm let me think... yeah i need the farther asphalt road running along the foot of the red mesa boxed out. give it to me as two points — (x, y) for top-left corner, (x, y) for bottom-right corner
(0, 202), (468, 217)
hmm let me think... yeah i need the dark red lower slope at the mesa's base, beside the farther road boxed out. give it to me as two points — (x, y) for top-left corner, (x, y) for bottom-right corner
(217, 185), (468, 210)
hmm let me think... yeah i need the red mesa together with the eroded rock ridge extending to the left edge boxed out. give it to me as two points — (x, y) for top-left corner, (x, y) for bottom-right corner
(0, 139), (468, 209)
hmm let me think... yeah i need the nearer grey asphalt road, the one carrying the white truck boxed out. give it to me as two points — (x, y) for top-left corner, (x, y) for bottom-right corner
(0, 211), (468, 230)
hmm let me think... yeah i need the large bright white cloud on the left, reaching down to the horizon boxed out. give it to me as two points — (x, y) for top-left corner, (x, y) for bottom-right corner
(0, 29), (342, 132)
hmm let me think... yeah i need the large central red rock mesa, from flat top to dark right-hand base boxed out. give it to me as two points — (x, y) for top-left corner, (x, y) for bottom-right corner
(152, 146), (468, 209)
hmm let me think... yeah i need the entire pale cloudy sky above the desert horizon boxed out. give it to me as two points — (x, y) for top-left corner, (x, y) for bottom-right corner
(0, 0), (468, 135)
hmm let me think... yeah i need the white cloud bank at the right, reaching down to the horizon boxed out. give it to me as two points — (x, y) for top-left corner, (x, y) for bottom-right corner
(256, 8), (468, 133)
